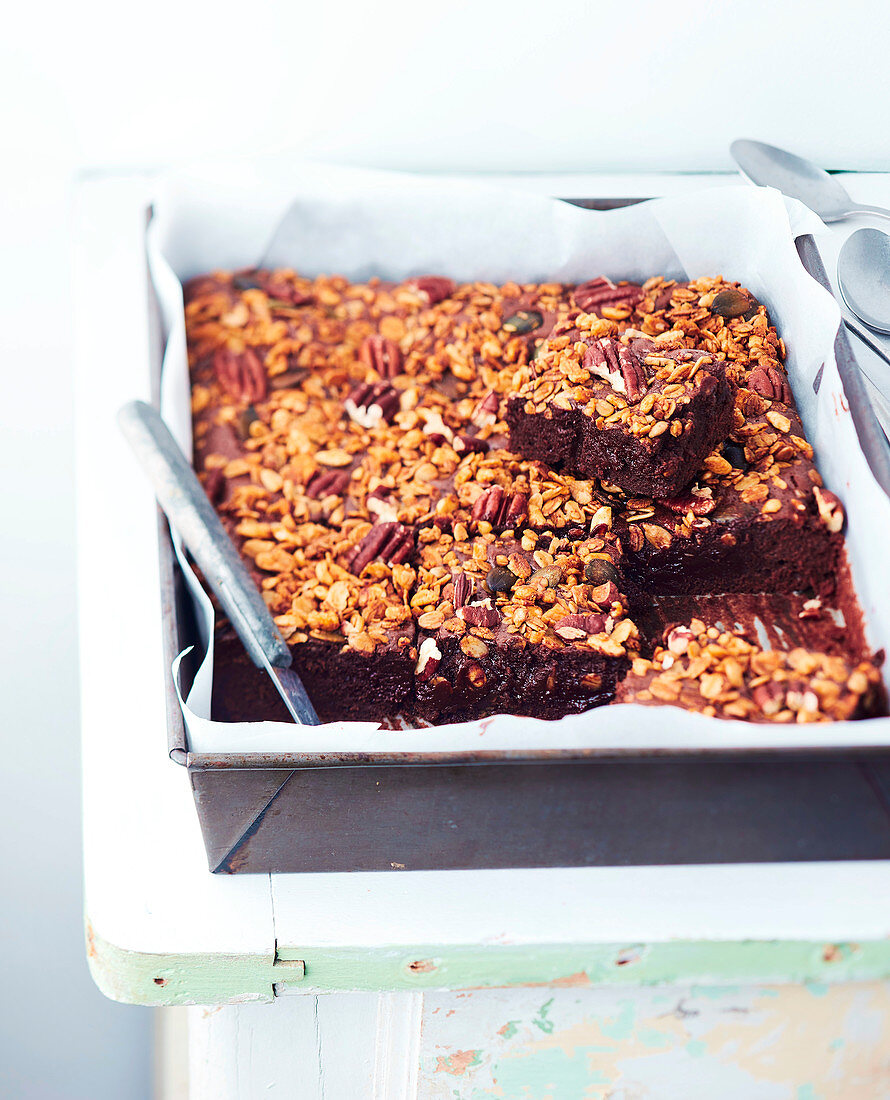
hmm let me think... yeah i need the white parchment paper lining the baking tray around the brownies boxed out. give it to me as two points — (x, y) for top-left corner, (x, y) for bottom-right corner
(147, 162), (890, 752)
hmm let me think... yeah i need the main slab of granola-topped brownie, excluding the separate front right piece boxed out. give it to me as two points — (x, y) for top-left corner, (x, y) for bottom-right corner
(186, 271), (880, 722)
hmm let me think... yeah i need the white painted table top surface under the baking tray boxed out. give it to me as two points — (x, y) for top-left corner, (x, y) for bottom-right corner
(75, 167), (890, 997)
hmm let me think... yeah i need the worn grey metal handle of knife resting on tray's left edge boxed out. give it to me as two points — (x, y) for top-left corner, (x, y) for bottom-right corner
(118, 402), (293, 669)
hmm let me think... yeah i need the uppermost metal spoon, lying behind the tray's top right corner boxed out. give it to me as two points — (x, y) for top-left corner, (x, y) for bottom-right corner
(729, 140), (890, 222)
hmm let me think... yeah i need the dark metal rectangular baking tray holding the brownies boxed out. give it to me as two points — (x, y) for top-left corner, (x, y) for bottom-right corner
(154, 198), (890, 873)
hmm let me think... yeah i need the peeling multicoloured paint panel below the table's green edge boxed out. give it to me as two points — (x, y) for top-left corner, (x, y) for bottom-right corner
(418, 981), (890, 1100)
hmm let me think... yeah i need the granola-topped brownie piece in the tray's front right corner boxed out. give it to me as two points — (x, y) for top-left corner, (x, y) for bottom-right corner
(617, 619), (881, 723)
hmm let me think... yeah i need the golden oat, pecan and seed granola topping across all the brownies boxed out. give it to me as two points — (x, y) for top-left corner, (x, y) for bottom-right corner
(186, 270), (877, 722)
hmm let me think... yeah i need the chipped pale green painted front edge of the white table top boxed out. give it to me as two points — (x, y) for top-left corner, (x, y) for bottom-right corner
(87, 930), (890, 1007)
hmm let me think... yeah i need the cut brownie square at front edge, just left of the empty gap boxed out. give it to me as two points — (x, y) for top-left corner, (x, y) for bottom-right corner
(411, 528), (637, 722)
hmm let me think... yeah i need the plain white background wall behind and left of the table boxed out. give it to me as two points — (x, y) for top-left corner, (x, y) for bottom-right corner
(0, 0), (890, 1100)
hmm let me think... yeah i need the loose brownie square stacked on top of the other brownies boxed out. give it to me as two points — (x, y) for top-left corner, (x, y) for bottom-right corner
(506, 314), (733, 497)
